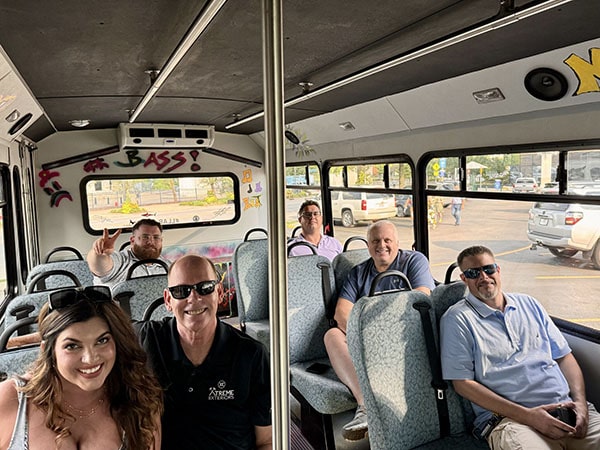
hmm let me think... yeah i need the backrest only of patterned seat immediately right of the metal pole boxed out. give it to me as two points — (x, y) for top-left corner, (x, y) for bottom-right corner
(288, 255), (334, 364)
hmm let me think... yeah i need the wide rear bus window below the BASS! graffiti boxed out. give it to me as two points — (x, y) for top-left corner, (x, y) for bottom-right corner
(82, 174), (240, 232)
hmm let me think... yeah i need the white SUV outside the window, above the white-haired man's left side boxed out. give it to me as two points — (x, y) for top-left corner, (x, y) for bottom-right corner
(331, 191), (396, 227)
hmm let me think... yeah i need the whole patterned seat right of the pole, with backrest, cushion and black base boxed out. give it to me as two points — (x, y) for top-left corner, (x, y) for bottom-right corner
(288, 255), (356, 448)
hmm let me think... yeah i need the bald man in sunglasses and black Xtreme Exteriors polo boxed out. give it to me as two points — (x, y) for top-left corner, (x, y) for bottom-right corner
(135, 255), (272, 450)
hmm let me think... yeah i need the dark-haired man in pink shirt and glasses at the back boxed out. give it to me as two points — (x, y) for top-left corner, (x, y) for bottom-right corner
(288, 200), (342, 261)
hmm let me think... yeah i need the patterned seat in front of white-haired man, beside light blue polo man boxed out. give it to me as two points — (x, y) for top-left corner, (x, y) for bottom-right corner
(347, 291), (487, 450)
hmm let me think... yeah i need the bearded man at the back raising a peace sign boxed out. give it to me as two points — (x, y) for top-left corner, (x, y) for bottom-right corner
(87, 219), (170, 287)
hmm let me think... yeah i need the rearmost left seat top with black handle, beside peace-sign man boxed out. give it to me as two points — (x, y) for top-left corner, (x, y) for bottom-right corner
(25, 247), (94, 291)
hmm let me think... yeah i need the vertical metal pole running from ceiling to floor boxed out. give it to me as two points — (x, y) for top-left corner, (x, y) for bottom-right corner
(263, 0), (290, 450)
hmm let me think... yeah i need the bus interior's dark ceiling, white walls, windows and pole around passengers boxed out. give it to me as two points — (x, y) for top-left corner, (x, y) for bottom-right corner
(0, 0), (600, 450)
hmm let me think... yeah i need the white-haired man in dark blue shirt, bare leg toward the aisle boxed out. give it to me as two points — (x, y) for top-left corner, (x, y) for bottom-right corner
(325, 220), (435, 440)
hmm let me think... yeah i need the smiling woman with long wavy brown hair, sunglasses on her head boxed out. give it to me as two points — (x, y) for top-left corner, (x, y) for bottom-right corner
(0, 286), (162, 450)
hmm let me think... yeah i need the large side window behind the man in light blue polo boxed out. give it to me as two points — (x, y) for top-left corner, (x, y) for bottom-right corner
(426, 149), (600, 329)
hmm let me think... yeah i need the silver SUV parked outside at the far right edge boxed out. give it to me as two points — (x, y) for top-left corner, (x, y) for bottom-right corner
(527, 202), (600, 269)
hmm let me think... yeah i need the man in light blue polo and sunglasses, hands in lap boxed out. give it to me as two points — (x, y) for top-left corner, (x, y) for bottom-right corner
(440, 246), (600, 450)
